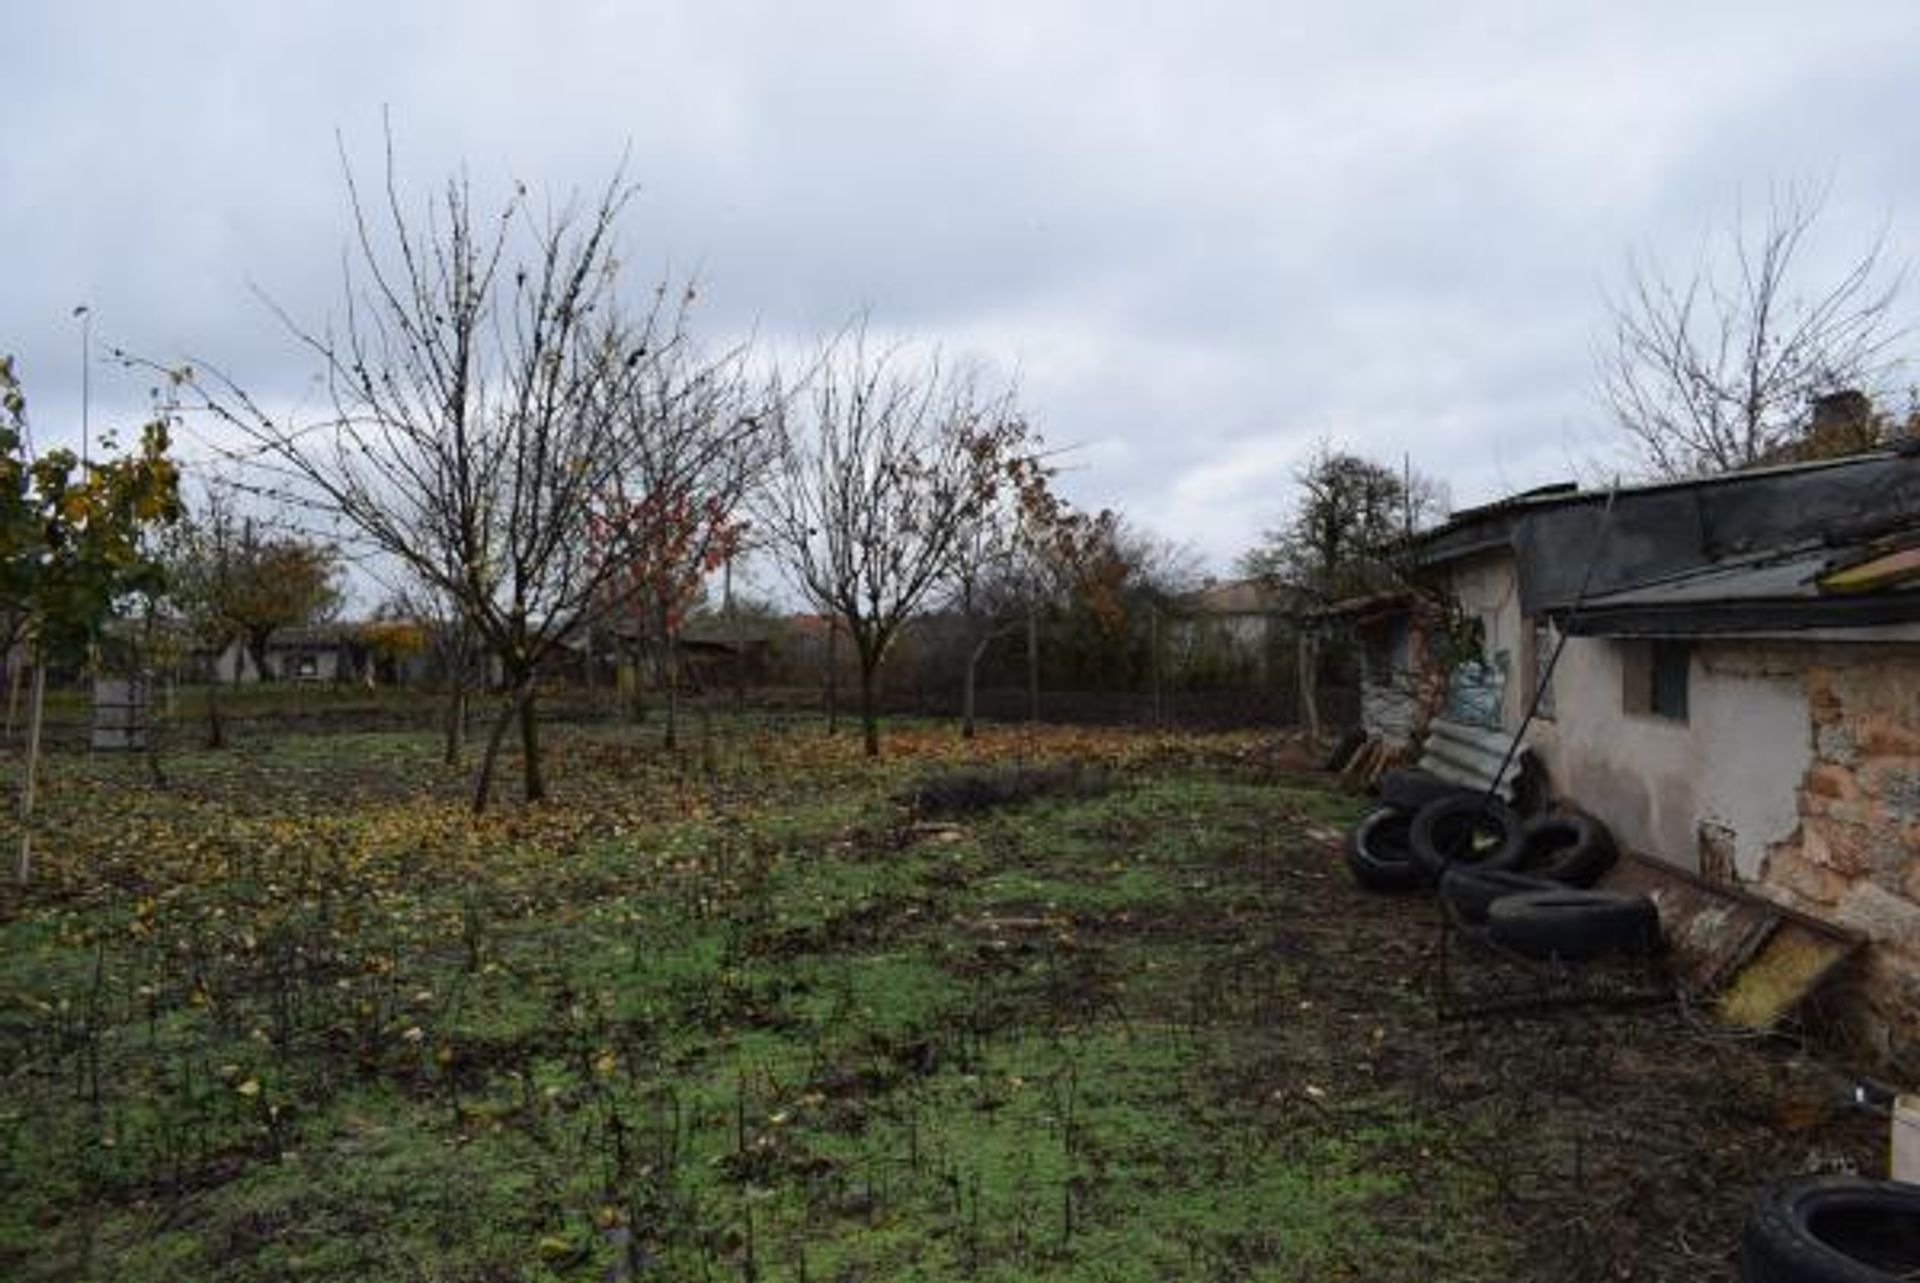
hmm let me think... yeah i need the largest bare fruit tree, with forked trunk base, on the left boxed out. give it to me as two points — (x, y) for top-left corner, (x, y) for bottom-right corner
(168, 138), (684, 809)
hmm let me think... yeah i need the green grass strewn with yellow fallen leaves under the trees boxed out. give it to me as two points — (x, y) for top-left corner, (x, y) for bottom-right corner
(0, 732), (1511, 1283)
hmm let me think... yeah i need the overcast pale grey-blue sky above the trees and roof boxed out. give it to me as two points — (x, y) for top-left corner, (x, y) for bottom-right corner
(0, 0), (1920, 570)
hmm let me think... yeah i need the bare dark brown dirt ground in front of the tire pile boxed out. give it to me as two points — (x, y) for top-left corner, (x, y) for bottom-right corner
(1236, 768), (1887, 1283)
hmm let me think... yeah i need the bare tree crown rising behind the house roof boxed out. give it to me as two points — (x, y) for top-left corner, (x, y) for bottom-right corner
(1596, 188), (1903, 476)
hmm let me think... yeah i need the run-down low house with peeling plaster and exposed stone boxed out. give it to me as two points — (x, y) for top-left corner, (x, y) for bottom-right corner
(1342, 451), (1920, 1064)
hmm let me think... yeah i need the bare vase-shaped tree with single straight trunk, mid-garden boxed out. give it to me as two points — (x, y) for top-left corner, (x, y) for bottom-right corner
(762, 323), (1025, 757)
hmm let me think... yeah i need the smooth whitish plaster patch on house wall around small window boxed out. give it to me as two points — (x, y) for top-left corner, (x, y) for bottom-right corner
(1528, 638), (1812, 880)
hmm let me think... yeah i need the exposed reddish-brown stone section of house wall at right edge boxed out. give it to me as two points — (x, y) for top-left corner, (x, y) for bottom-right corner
(1753, 643), (1920, 1081)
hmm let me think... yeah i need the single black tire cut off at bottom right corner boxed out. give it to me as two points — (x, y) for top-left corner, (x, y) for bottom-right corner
(1740, 1175), (1920, 1283)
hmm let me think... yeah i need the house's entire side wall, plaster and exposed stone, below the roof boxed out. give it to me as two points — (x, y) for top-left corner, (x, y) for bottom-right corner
(1420, 553), (1920, 1068)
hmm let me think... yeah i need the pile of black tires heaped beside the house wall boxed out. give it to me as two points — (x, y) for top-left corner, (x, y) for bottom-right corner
(1346, 770), (1659, 962)
